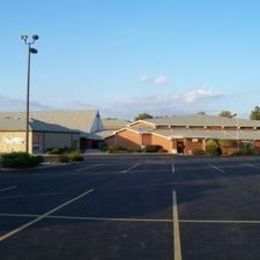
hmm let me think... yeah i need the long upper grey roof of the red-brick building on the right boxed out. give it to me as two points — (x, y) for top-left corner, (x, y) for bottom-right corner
(143, 115), (260, 127)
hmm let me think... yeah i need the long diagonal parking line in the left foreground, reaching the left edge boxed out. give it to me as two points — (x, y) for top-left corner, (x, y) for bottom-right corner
(0, 189), (94, 242)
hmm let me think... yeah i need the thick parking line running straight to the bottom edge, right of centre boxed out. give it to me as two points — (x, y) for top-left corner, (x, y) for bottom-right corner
(172, 190), (182, 260)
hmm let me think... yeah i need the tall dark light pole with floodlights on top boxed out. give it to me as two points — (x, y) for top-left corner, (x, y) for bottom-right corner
(21, 34), (39, 153)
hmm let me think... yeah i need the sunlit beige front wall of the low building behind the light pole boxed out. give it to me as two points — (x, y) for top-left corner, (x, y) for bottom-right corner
(0, 132), (32, 153)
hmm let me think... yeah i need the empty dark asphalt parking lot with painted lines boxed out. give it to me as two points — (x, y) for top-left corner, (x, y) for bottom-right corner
(0, 155), (260, 260)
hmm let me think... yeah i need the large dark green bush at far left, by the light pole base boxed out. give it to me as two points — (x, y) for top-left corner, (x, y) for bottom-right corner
(1, 152), (43, 168)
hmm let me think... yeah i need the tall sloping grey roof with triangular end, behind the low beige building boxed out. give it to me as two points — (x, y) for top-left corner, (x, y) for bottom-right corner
(0, 110), (103, 135)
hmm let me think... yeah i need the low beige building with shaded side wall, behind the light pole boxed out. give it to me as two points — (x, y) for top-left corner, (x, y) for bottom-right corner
(0, 118), (80, 153)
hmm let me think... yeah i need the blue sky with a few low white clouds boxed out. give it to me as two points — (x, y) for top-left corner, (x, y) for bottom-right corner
(0, 0), (260, 118)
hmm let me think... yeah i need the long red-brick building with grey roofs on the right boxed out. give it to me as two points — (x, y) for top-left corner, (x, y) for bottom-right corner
(106, 115), (260, 154)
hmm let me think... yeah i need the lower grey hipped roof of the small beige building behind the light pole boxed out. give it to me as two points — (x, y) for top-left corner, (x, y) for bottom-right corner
(0, 118), (79, 133)
